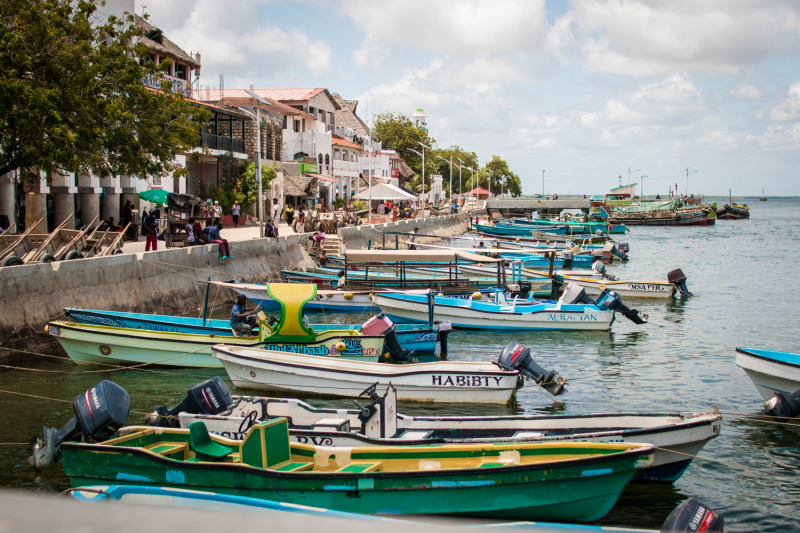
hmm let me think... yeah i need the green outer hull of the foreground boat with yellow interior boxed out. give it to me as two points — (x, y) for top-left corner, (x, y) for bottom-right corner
(61, 436), (652, 522)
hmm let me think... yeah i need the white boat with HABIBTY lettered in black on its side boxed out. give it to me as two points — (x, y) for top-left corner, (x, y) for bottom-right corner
(212, 344), (521, 403)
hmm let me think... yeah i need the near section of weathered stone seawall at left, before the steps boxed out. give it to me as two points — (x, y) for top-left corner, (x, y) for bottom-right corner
(0, 234), (313, 352)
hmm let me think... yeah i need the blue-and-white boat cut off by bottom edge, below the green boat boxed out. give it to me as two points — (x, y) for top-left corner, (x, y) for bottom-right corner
(70, 485), (658, 533)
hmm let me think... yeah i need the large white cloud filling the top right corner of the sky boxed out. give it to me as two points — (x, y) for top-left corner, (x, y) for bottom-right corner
(554, 0), (800, 76)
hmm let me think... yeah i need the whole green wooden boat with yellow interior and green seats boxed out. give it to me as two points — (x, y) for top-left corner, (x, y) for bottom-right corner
(61, 418), (653, 521)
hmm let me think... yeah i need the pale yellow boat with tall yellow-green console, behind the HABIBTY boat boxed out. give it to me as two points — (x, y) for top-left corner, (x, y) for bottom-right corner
(47, 283), (384, 368)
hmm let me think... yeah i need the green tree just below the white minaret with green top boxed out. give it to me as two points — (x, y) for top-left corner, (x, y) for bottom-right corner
(373, 113), (438, 190)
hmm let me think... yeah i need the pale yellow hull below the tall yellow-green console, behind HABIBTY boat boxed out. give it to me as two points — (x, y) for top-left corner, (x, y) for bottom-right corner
(48, 323), (384, 368)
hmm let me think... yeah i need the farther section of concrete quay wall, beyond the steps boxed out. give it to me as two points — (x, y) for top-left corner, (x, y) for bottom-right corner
(337, 211), (476, 250)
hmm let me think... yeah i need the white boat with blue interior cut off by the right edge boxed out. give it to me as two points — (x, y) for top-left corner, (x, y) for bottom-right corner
(736, 348), (800, 400)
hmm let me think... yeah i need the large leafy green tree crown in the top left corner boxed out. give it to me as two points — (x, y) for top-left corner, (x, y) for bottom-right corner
(0, 0), (211, 184)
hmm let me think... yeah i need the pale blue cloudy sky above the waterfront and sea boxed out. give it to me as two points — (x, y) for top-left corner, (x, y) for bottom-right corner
(145, 0), (800, 195)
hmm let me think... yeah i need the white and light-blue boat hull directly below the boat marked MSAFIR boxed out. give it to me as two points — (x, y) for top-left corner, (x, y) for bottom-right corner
(374, 293), (614, 331)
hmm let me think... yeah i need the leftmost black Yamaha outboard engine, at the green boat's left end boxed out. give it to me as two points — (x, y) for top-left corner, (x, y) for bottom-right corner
(28, 380), (131, 472)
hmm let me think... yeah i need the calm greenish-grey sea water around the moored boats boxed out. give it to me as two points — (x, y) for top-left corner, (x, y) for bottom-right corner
(0, 199), (800, 531)
